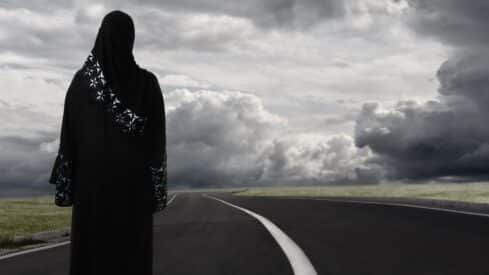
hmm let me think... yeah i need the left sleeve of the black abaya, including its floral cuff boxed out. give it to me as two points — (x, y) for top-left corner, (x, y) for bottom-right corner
(49, 75), (76, 206)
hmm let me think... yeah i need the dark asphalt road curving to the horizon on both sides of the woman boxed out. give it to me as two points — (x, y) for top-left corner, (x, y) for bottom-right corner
(0, 193), (489, 275)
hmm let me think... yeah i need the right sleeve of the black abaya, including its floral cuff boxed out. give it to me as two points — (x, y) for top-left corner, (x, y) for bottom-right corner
(146, 73), (167, 213)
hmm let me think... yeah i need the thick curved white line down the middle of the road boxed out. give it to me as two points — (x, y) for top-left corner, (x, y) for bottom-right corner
(203, 194), (317, 275)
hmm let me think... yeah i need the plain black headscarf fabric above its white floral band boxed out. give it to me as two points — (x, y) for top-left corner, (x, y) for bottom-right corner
(92, 10), (139, 103)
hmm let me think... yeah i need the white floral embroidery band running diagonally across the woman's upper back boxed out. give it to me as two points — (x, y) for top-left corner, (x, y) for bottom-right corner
(82, 53), (147, 135)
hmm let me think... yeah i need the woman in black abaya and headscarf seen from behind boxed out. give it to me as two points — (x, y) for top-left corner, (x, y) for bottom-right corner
(49, 11), (167, 275)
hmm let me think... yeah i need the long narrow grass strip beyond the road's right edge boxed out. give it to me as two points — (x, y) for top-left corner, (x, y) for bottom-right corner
(235, 183), (489, 203)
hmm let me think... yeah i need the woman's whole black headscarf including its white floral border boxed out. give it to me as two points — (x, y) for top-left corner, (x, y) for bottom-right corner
(82, 11), (146, 135)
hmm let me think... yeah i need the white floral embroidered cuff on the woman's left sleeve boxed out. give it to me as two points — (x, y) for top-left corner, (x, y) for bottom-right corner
(50, 154), (73, 206)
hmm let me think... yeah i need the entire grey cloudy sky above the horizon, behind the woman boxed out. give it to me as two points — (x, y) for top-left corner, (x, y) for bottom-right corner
(0, 0), (489, 195)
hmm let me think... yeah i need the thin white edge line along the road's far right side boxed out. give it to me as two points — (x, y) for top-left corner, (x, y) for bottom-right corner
(255, 196), (489, 218)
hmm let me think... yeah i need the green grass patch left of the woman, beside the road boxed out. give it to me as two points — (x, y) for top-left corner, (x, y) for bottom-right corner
(0, 196), (71, 248)
